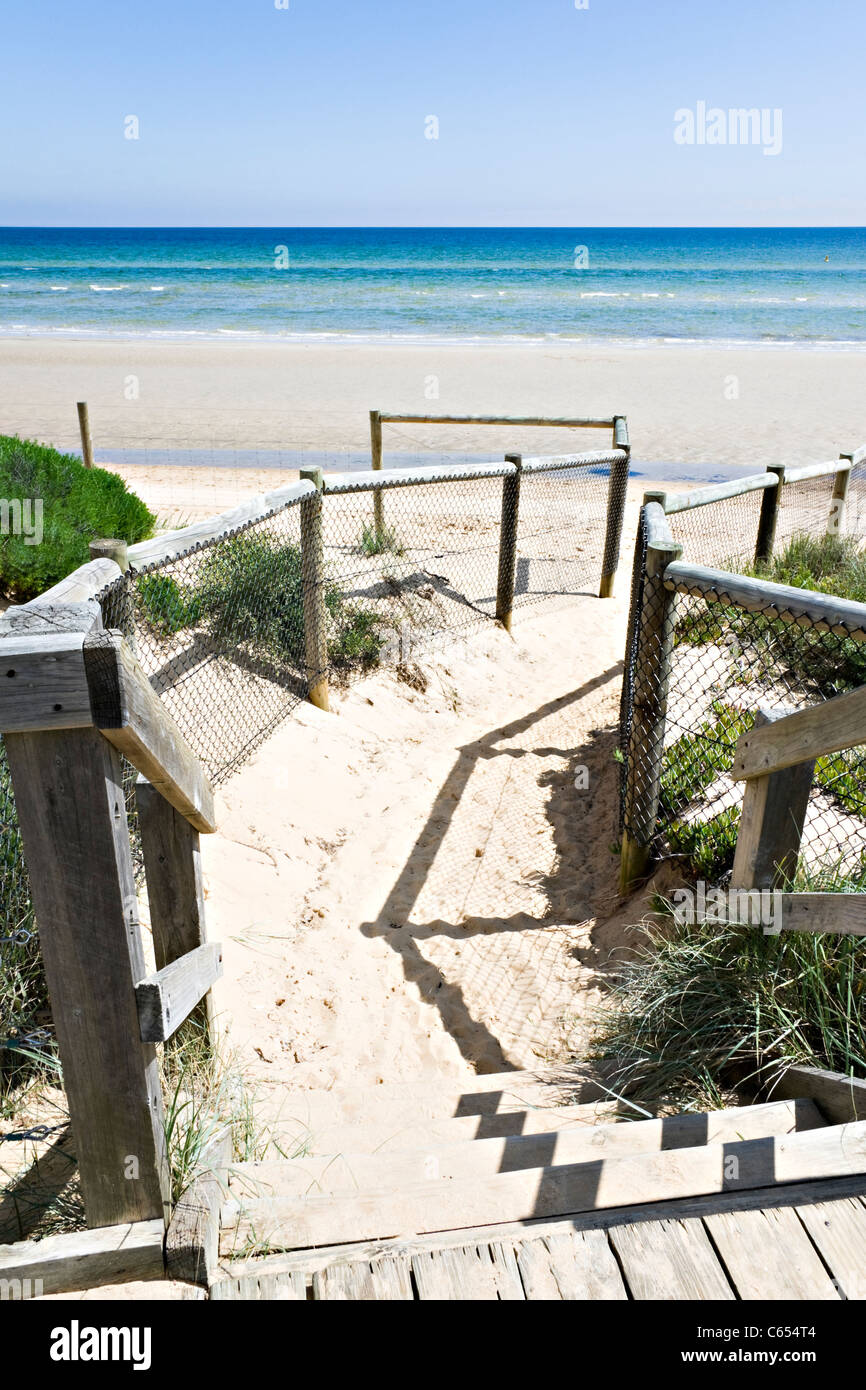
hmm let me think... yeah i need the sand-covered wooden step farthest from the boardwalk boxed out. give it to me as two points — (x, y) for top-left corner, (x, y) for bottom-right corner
(271, 1063), (616, 1134)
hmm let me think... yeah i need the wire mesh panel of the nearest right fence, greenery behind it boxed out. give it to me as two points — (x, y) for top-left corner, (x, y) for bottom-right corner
(620, 514), (866, 887)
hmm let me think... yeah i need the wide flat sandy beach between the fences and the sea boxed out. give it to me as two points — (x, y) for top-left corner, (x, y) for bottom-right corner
(0, 338), (866, 466)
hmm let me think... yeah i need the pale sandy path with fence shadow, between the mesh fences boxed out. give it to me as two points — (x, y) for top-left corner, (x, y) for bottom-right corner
(204, 586), (636, 1112)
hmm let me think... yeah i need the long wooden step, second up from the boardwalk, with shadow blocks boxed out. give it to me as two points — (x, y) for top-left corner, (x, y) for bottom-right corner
(229, 1101), (824, 1197)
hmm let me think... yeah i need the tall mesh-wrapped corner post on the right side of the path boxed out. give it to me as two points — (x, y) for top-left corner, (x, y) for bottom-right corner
(620, 502), (683, 895)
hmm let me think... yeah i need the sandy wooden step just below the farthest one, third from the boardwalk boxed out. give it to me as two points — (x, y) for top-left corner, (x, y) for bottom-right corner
(270, 1101), (619, 1158)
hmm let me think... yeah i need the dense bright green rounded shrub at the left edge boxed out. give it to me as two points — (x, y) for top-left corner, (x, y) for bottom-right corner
(0, 435), (154, 599)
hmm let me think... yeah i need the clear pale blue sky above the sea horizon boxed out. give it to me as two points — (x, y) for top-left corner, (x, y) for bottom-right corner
(0, 0), (866, 227)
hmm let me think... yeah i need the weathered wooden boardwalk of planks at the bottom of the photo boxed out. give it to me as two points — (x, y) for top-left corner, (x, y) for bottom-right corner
(210, 1177), (866, 1302)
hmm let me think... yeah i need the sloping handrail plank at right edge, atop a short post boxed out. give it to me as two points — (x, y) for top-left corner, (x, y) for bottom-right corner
(731, 683), (866, 781)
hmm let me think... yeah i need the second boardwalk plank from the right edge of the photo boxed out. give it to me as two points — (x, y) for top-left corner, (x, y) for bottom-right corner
(703, 1207), (840, 1301)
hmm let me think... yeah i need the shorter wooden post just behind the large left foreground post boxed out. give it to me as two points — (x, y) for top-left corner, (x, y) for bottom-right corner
(135, 777), (215, 1044)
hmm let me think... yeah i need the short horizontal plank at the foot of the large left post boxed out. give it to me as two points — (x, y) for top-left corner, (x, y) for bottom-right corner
(0, 1218), (165, 1295)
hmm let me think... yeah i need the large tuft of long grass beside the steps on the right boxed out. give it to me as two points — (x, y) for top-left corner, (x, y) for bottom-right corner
(592, 906), (866, 1111)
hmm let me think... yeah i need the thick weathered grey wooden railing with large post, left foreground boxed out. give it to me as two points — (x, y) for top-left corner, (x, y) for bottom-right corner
(0, 572), (221, 1226)
